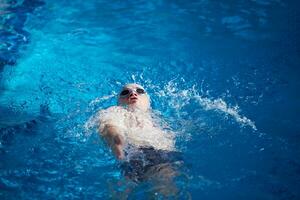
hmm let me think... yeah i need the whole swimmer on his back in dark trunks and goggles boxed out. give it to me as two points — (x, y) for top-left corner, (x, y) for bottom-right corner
(99, 84), (178, 195)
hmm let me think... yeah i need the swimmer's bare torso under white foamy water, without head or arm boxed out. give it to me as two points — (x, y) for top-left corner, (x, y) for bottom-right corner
(100, 106), (175, 151)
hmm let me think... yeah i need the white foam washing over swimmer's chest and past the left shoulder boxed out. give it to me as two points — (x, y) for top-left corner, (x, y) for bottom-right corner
(84, 106), (174, 150)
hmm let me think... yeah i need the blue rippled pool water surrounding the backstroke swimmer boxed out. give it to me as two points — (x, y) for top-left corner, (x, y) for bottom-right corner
(0, 0), (300, 199)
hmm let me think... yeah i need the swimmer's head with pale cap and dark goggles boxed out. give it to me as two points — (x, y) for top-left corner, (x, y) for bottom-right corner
(118, 83), (150, 111)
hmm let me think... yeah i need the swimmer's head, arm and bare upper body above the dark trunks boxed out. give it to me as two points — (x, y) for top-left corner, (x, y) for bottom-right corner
(99, 84), (174, 160)
